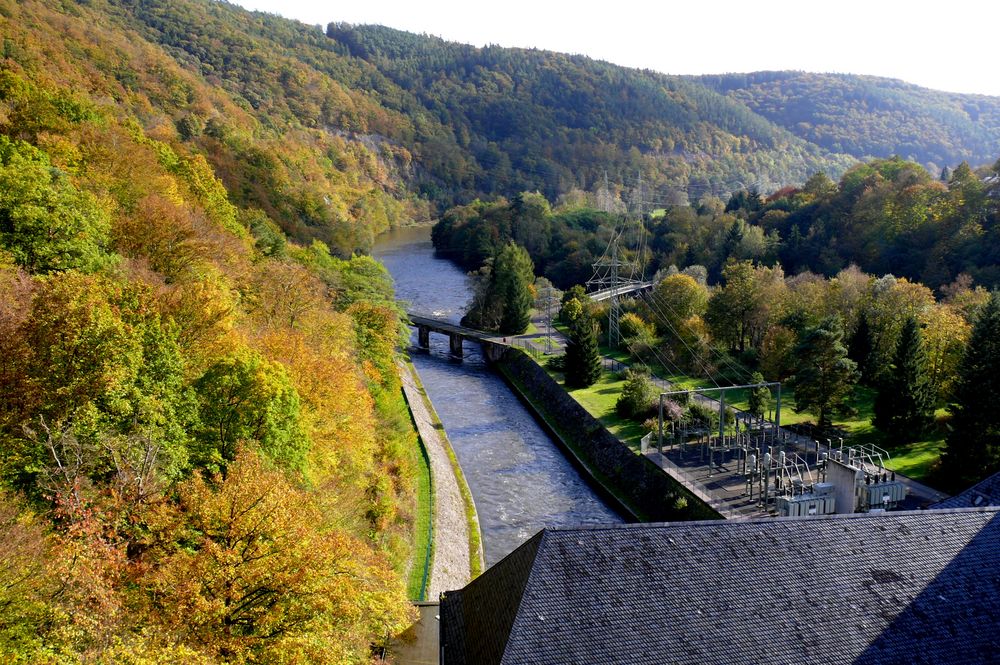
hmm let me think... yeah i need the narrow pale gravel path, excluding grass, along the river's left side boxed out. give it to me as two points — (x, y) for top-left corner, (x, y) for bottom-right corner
(400, 365), (470, 600)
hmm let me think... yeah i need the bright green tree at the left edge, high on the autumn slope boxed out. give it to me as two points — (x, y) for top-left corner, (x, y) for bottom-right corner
(0, 135), (111, 273)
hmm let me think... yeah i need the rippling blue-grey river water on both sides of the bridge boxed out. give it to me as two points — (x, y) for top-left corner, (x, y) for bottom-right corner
(373, 227), (622, 565)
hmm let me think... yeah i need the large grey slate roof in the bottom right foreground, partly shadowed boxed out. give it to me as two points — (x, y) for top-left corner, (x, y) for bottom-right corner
(441, 508), (1000, 665)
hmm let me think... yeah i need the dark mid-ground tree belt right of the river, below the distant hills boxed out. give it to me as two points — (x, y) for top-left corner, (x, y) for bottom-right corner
(433, 157), (1000, 289)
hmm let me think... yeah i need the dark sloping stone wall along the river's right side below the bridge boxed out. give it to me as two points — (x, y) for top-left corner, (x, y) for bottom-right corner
(494, 349), (721, 522)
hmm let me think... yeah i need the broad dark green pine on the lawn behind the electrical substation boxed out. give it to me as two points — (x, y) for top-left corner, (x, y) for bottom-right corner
(792, 317), (858, 428)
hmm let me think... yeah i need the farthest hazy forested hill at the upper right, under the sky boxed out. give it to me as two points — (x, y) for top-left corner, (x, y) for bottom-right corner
(694, 71), (1000, 175)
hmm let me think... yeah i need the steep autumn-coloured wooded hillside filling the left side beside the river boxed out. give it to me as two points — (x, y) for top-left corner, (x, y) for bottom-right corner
(0, 0), (418, 663)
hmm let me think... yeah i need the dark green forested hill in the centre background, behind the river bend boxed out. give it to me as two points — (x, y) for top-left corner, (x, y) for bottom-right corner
(327, 24), (853, 202)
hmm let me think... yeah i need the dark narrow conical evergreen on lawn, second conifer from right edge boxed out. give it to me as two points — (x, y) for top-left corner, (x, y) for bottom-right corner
(875, 317), (934, 442)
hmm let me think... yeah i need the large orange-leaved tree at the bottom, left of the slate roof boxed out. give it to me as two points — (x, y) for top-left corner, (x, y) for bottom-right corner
(138, 451), (410, 663)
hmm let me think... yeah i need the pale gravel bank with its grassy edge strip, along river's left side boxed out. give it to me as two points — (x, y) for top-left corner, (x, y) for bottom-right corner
(399, 363), (483, 600)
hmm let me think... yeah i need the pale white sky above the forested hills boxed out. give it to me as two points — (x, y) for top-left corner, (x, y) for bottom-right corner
(234, 0), (1000, 95)
